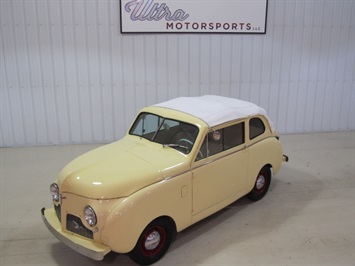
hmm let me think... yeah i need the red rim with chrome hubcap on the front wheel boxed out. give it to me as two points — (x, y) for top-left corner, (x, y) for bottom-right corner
(141, 226), (166, 257)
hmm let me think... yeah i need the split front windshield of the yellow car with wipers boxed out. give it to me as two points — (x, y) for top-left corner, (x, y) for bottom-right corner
(129, 113), (198, 154)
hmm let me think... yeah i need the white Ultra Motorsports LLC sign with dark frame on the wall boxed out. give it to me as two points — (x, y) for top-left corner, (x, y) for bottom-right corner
(120, 0), (267, 34)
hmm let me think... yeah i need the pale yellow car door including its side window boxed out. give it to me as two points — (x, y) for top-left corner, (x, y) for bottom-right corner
(192, 122), (248, 220)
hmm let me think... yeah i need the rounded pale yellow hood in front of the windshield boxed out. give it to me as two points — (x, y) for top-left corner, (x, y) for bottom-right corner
(57, 135), (187, 199)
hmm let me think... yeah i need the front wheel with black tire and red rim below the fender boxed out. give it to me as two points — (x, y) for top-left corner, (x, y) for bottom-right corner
(129, 219), (173, 265)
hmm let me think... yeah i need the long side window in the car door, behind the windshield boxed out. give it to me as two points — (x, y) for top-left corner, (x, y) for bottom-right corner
(196, 122), (245, 161)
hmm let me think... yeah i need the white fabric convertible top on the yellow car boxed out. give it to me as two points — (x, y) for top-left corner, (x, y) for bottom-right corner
(154, 95), (274, 131)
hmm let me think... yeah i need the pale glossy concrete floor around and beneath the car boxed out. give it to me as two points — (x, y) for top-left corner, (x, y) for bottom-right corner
(0, 132), (355, 266)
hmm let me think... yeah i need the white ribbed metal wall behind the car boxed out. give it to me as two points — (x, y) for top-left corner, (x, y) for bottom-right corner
(0, 0), (355, 146)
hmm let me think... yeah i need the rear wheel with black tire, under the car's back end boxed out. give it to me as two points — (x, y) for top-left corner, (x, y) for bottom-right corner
(247, 166), (271, 201)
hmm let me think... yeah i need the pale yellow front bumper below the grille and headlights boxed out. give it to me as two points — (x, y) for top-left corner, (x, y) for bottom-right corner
(41, 208), (111, 260)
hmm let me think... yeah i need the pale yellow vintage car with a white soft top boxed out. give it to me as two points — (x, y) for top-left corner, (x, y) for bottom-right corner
(41, 95), (288, 265)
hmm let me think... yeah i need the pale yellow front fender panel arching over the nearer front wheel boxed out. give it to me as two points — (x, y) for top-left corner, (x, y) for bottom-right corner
(101, 172), (192, 253)
